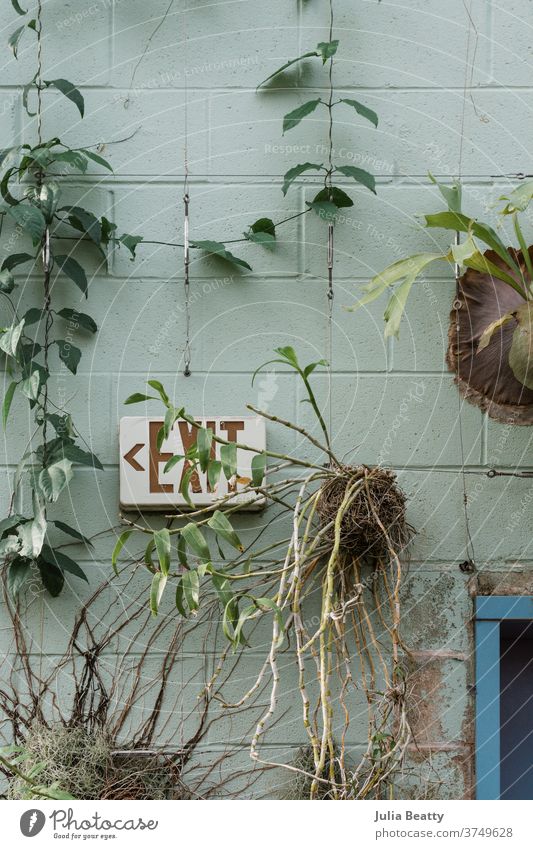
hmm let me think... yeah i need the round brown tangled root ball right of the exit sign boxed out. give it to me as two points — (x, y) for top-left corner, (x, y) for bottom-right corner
(317, 466), (413, 563)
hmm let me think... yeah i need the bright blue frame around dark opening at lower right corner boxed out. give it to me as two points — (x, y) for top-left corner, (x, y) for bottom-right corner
(475, 596), (533, 799)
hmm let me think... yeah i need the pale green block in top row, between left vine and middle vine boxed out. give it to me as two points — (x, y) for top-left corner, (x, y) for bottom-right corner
(112, 0), (298, 89)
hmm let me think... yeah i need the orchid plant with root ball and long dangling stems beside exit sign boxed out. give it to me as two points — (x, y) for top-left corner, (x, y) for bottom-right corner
(118, 346), (412, 798)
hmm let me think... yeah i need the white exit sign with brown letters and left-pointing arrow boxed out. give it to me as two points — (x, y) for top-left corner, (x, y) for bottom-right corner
(120, 416), (266, 510)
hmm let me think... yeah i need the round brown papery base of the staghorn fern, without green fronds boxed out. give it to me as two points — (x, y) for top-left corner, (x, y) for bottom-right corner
(447, 247), (533, 425)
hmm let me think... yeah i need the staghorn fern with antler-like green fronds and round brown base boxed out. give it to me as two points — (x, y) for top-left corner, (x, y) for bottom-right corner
(349, 175), (533, 424)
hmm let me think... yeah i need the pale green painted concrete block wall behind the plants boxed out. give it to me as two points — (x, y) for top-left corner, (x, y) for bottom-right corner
(0, 0), (533, 797)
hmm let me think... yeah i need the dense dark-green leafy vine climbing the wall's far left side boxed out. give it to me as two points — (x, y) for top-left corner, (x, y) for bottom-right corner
(0, 0), (141, 597)
